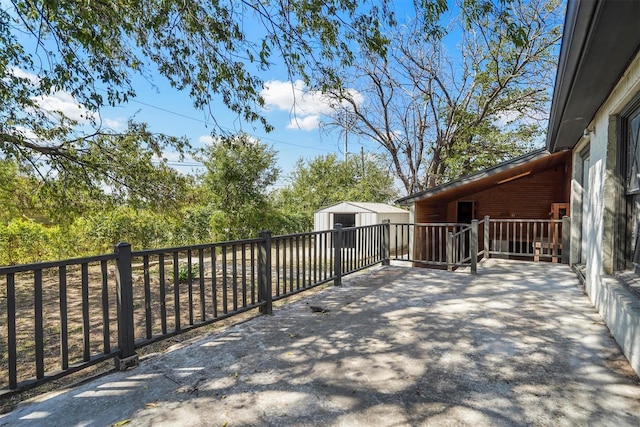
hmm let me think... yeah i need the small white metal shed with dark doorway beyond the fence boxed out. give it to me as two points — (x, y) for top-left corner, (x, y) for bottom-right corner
(313, 202), (409, 251)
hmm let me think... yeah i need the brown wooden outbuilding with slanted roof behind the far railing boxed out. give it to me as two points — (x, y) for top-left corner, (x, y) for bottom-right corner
(398, 149), (571, 223)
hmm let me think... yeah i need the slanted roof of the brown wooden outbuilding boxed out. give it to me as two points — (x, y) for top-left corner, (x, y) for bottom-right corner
(396, 149), (571, 205)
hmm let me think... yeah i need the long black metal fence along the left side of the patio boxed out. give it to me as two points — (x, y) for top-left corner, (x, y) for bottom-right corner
(0, 223), (390, 395)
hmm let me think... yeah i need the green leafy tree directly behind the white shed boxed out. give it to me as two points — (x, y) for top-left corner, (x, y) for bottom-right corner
(274, 153), (397, 230)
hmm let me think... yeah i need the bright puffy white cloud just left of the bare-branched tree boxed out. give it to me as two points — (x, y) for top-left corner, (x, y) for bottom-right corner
(260, 80), (363, 130)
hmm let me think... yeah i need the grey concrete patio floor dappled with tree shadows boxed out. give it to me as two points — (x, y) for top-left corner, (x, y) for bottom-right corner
(0, 259), (640, 427)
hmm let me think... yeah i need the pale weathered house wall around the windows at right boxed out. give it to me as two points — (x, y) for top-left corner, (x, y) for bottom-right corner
(571, 49), (640, 374)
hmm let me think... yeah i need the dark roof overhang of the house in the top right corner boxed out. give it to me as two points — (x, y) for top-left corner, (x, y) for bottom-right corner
(547, 0), (640, 152)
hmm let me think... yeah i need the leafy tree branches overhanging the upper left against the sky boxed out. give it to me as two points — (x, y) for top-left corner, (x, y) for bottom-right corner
(0, 0), (400, 199)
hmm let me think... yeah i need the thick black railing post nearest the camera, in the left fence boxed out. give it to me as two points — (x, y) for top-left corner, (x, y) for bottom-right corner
(115, 242), (139, 371)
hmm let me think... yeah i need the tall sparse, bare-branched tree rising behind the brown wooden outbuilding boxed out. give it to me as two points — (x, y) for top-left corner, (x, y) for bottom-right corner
(324, 0), (560, 194)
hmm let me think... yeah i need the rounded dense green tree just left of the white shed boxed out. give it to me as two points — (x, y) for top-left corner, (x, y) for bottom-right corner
(201, 134), (279, 238)
